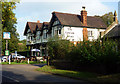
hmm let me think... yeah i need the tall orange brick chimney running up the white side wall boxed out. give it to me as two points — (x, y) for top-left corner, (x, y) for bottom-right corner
(81, 6), (88, 41)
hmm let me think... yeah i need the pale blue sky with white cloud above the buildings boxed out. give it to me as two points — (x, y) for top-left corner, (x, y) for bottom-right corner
(14, 0), (120, 40)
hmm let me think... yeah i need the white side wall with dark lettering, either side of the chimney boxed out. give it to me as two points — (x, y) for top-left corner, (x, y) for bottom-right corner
(61, 26), (105, 41)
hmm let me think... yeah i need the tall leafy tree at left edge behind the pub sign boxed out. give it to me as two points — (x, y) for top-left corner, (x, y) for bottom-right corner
(2, 2), (19, 53)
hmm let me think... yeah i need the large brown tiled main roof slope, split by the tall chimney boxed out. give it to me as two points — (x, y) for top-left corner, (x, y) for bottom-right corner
(52, 12), (107, 28)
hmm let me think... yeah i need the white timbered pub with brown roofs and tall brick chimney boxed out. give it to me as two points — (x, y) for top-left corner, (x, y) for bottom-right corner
(24, 7), (107, 56)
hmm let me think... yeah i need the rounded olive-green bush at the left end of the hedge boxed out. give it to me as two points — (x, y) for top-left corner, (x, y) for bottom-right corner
(47, 36), (72, 59)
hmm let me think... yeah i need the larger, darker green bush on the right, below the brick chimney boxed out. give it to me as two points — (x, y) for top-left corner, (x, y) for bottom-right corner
(69, 41), (119, 65)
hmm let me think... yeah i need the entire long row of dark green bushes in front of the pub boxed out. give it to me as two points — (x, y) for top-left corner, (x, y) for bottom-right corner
(48, 36), (120, 73)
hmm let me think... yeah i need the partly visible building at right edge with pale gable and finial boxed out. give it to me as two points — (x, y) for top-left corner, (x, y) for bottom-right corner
(102, 11), (120, 50)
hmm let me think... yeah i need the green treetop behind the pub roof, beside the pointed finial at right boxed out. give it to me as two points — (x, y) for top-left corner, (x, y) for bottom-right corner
(101, 12), (114, 26)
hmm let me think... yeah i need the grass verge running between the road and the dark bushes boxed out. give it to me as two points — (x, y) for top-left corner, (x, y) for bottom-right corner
(36, 65), (120, 84)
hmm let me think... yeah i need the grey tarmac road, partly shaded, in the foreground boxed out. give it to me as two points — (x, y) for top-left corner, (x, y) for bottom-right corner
(2, 65), (91, 84)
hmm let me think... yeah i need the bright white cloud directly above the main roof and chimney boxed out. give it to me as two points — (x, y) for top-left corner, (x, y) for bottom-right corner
(45, 0), (110, 16)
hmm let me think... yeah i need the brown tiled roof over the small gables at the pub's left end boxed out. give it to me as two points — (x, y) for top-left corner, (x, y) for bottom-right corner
(24, 22), (42, 35)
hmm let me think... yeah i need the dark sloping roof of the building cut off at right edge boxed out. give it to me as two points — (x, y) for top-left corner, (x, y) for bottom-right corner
(104, 24), (120, 38)
